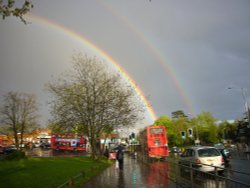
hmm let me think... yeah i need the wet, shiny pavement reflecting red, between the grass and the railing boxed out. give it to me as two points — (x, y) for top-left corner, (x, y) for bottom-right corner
(82, 155), (176, 188)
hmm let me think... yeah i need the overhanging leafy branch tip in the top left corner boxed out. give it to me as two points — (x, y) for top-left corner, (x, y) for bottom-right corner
(0, 0), (33, 24)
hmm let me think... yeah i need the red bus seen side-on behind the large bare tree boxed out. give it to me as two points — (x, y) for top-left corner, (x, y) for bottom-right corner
(50, 135), (87, 151)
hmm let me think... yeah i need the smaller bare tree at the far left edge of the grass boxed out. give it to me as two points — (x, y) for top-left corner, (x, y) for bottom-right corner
(1, 92), (38, 150)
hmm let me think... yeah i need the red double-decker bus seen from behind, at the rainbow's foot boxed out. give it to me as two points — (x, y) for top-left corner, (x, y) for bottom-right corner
(139, 125), (169, 158)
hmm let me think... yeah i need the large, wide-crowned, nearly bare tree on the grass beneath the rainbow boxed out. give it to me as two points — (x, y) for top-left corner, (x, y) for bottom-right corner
(48, 54), (144, 158)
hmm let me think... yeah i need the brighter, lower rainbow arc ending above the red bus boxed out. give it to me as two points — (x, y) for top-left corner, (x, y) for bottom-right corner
(27, 14), (157, 121)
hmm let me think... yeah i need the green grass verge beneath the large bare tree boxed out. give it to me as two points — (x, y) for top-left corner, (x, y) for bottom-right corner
(0, 157), (111, 188)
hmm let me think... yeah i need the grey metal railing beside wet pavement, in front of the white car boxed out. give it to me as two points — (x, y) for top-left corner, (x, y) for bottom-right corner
(167, 158), (250, 188)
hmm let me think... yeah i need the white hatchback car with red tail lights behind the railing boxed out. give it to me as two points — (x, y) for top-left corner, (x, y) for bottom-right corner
(180, 146), (225, 172)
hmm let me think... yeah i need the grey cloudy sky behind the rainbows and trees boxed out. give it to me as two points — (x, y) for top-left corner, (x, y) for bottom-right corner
(0, 0), (250, 128)
